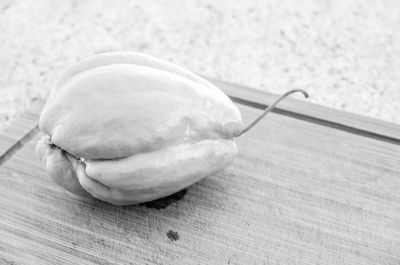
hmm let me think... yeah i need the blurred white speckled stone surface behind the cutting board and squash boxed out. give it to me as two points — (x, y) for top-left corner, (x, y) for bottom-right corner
(0, 0), (400, 130)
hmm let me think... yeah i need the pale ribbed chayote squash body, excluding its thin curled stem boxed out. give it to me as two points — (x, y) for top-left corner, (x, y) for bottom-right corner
(36, 52), (243, 205)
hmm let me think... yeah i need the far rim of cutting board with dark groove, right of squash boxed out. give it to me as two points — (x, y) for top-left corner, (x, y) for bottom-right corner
(205, 77), (400, 144)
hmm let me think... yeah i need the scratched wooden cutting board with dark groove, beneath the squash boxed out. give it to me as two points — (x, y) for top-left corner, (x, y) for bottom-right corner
(0, 80), (400, 265)
